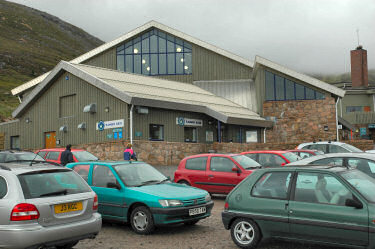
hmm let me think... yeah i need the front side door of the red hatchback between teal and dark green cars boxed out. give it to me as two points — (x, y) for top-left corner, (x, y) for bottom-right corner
(207, 156), (241, 193)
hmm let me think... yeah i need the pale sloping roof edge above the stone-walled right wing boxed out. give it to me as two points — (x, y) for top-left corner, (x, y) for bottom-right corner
(252, 55), (345, 98)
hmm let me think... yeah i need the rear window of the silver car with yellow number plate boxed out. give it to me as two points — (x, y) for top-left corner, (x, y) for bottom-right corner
(18, 170), (91, 199)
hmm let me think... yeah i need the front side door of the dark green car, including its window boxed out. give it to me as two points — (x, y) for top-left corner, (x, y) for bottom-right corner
(289, 170), (368, 246)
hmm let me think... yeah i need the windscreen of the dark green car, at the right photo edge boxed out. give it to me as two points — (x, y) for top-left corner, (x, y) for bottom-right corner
(341, 170), (375, 202)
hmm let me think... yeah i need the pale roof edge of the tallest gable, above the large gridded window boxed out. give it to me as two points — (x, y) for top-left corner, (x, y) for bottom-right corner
(12, 21), (253, 95)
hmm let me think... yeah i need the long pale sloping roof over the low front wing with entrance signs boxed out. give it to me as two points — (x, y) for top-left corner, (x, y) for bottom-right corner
(12, 61), (272, 127)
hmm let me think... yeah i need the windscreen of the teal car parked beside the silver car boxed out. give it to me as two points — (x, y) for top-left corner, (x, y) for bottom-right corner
(113, 163), (168, 187)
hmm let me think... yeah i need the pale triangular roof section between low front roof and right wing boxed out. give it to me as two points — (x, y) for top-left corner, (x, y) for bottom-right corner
(193, 79), (258, 112)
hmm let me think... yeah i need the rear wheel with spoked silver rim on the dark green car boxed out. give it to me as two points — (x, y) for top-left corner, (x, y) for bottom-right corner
(231, 218), (261, 248)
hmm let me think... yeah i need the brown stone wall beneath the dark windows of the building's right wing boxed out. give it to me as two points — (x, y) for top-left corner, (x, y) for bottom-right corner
(263, 98), (336, 143)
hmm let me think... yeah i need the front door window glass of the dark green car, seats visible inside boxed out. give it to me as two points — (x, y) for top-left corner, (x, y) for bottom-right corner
(294, 172), (352, 206)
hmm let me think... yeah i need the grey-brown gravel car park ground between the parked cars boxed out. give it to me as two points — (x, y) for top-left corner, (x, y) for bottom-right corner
(74, 166), (348, 249)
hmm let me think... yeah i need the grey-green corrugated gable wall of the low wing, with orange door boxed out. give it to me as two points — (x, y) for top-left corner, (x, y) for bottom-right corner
(0, 73), (129, 149)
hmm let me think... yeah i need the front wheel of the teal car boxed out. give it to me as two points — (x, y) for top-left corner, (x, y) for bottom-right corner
(130, 206), (155, 234)
